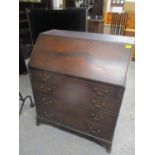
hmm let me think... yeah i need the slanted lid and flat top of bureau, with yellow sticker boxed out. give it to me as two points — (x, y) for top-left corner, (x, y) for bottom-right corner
(29, 30), (134, 86)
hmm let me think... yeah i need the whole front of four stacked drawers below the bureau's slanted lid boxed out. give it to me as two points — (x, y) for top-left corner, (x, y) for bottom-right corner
(30, 71), (122, 140)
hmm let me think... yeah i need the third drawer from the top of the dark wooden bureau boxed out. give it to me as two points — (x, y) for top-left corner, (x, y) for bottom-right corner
(34, 93), (117, 129)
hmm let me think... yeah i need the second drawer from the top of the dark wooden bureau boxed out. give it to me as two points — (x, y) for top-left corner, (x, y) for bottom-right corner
(32, 78), (121, 114)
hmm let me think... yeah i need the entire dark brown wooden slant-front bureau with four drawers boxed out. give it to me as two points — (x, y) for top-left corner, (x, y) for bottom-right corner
(29, 30), (134, 151)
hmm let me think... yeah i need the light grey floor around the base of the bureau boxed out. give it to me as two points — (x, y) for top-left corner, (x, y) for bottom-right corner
(19, 62), (135, 155)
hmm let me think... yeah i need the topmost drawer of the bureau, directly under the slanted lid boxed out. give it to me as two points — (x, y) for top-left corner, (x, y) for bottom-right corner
(31, 71), (124, 103)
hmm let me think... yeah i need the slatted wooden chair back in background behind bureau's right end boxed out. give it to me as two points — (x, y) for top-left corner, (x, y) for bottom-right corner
(110, 13), (128, 35)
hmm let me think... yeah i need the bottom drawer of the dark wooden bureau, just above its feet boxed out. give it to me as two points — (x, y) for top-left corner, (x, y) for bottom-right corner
(37, 108), (114, 141)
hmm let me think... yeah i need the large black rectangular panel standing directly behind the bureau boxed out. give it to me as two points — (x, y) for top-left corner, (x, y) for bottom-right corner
(28, 8), (87, 43)
